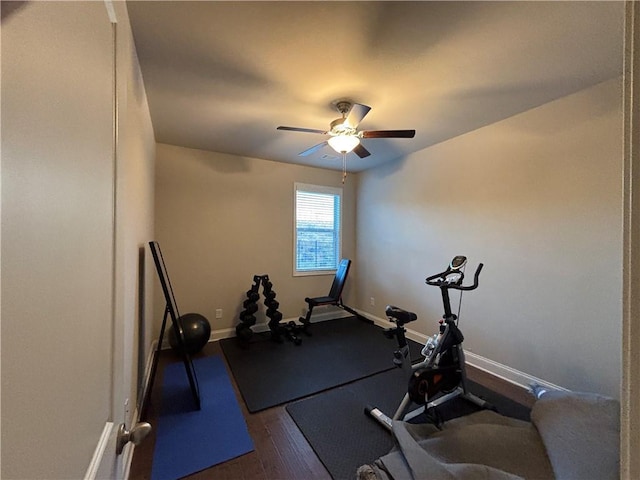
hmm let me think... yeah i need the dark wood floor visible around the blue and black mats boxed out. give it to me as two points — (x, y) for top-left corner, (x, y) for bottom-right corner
(129, 342), (533, 480)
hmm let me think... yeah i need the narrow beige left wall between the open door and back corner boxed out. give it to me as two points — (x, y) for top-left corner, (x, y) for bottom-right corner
(116, 3), (156, 424)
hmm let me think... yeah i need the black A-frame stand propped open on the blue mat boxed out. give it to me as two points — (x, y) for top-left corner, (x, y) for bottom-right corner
(140, 242), (200, 419)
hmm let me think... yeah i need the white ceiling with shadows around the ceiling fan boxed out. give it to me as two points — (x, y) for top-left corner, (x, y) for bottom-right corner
(128, 1), (624, 172)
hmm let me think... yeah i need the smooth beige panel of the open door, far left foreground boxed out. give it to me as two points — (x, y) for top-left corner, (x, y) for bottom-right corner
(2, 3), (113, 478)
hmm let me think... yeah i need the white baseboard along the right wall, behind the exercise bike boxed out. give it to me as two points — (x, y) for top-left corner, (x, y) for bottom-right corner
(350, 310), (568, 391)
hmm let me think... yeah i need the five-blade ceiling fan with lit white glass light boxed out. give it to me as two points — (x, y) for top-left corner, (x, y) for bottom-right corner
(277, 101), (416, 158)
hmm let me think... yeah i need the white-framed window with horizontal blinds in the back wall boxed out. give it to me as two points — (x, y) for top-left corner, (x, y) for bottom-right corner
(293, 183), (342, 275)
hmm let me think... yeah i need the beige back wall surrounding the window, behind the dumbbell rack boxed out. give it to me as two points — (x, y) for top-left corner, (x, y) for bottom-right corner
(155, 144), (359, 333)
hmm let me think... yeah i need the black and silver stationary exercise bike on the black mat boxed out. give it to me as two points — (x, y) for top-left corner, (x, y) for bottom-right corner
(365, 255), (493, 430)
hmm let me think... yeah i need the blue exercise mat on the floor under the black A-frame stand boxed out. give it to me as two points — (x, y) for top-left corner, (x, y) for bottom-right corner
(151, 356), (253, 480)
